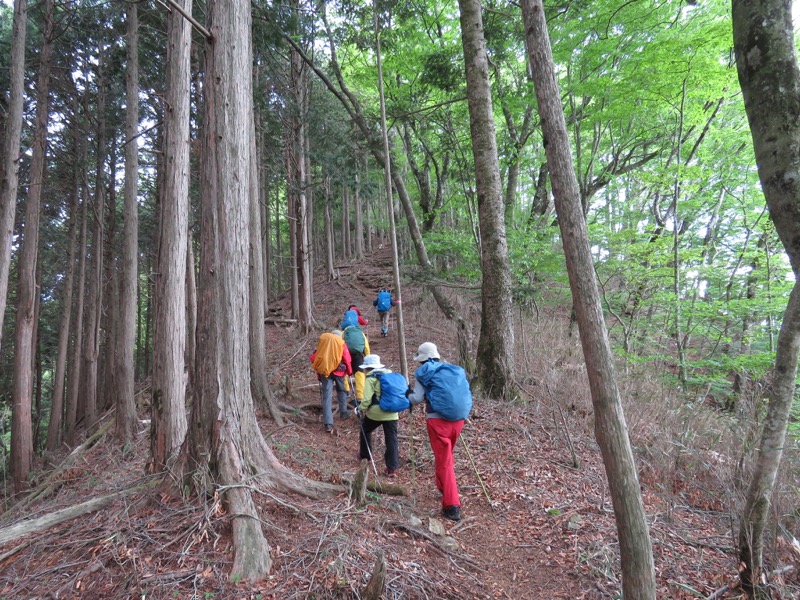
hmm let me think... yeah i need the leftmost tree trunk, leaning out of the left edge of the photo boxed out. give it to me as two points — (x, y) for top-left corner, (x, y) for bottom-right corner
(0, 0), (28, 354)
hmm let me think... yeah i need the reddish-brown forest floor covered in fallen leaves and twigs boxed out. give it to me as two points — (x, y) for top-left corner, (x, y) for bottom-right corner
(0, 249), (797, 600)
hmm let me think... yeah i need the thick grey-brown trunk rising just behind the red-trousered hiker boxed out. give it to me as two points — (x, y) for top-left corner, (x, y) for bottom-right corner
(458, 0), (516, 399)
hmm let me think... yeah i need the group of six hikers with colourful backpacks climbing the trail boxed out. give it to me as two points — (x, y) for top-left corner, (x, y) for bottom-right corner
(311, 288), (472, 521)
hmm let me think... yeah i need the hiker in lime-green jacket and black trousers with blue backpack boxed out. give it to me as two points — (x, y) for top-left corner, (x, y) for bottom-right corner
(358, 354), (410, 477)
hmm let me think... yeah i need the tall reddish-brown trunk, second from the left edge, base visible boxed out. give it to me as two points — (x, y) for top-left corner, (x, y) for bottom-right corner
(11, 0), (53, 491)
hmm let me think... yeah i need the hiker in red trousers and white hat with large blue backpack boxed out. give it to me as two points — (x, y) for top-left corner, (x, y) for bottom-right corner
(406, 342), (472, 521)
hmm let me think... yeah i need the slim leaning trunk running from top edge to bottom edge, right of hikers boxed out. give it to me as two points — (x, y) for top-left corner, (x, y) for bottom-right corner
(522, 0), (656, 600)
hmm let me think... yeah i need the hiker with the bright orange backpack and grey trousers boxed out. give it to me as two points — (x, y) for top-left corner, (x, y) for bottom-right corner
(311, 329), (353, 433)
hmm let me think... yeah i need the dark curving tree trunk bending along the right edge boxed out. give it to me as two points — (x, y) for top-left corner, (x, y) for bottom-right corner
(733, 0), (800, 598)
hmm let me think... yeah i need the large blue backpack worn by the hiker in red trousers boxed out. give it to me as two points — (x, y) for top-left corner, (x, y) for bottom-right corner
(414, 361), (472, 421)
